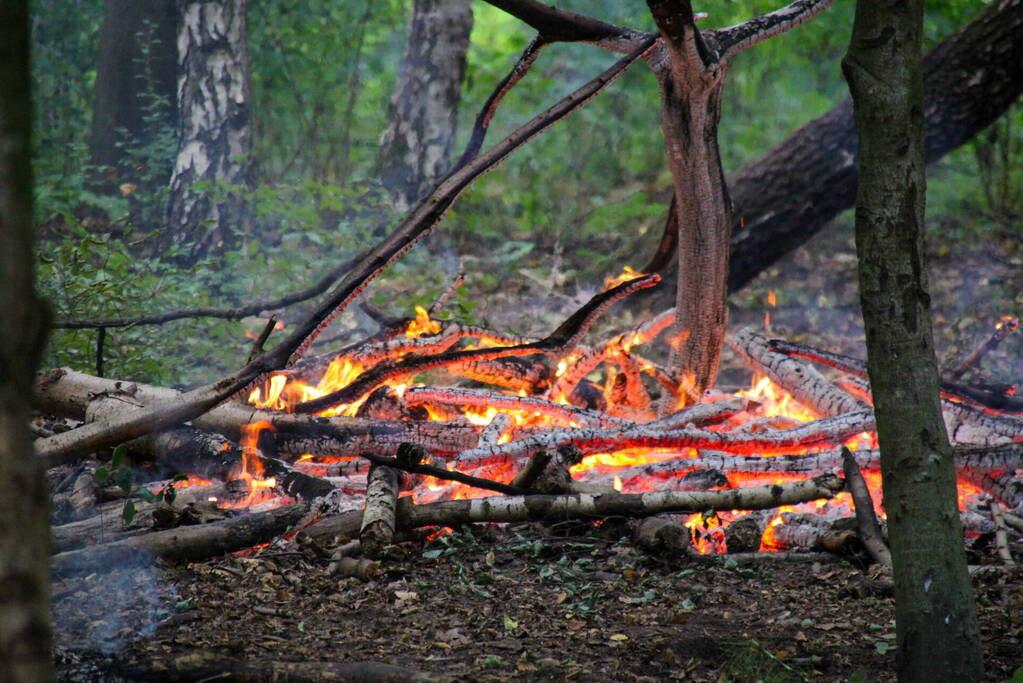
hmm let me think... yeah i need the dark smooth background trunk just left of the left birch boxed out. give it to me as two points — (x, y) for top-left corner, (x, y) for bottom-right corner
(89, 0), (178, 188)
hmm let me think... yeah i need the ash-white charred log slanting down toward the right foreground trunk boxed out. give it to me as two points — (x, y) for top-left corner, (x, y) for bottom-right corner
(727, 327), (864, 415)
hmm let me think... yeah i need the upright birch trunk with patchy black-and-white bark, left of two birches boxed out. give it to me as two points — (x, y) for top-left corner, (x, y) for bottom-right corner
(167, 0), (252, 260)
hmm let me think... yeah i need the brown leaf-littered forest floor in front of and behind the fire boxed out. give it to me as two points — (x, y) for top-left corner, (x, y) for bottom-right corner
(53, 222), (1023, 682)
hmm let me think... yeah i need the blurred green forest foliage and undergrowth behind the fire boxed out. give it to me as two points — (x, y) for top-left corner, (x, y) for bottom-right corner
(32, 0), (1023, 385)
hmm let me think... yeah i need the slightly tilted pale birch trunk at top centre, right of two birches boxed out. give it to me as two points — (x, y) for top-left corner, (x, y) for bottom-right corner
(380, 0), (473, 211)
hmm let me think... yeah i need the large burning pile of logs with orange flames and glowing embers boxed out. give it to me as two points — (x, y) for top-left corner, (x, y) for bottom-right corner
(38, 272), (1023, 576)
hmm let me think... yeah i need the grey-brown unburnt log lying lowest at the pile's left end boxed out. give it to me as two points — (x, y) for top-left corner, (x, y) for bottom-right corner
(52, 503), (309, 577)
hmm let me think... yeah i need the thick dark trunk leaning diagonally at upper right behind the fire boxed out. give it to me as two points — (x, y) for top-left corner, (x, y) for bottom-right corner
(728, 0), (1023, 291)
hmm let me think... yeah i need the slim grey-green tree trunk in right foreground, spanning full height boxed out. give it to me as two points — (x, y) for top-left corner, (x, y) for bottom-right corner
(842, 0), (982, 681)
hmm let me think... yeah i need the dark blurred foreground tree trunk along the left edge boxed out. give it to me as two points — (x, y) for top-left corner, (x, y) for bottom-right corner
(0, 0), (53, 681)
